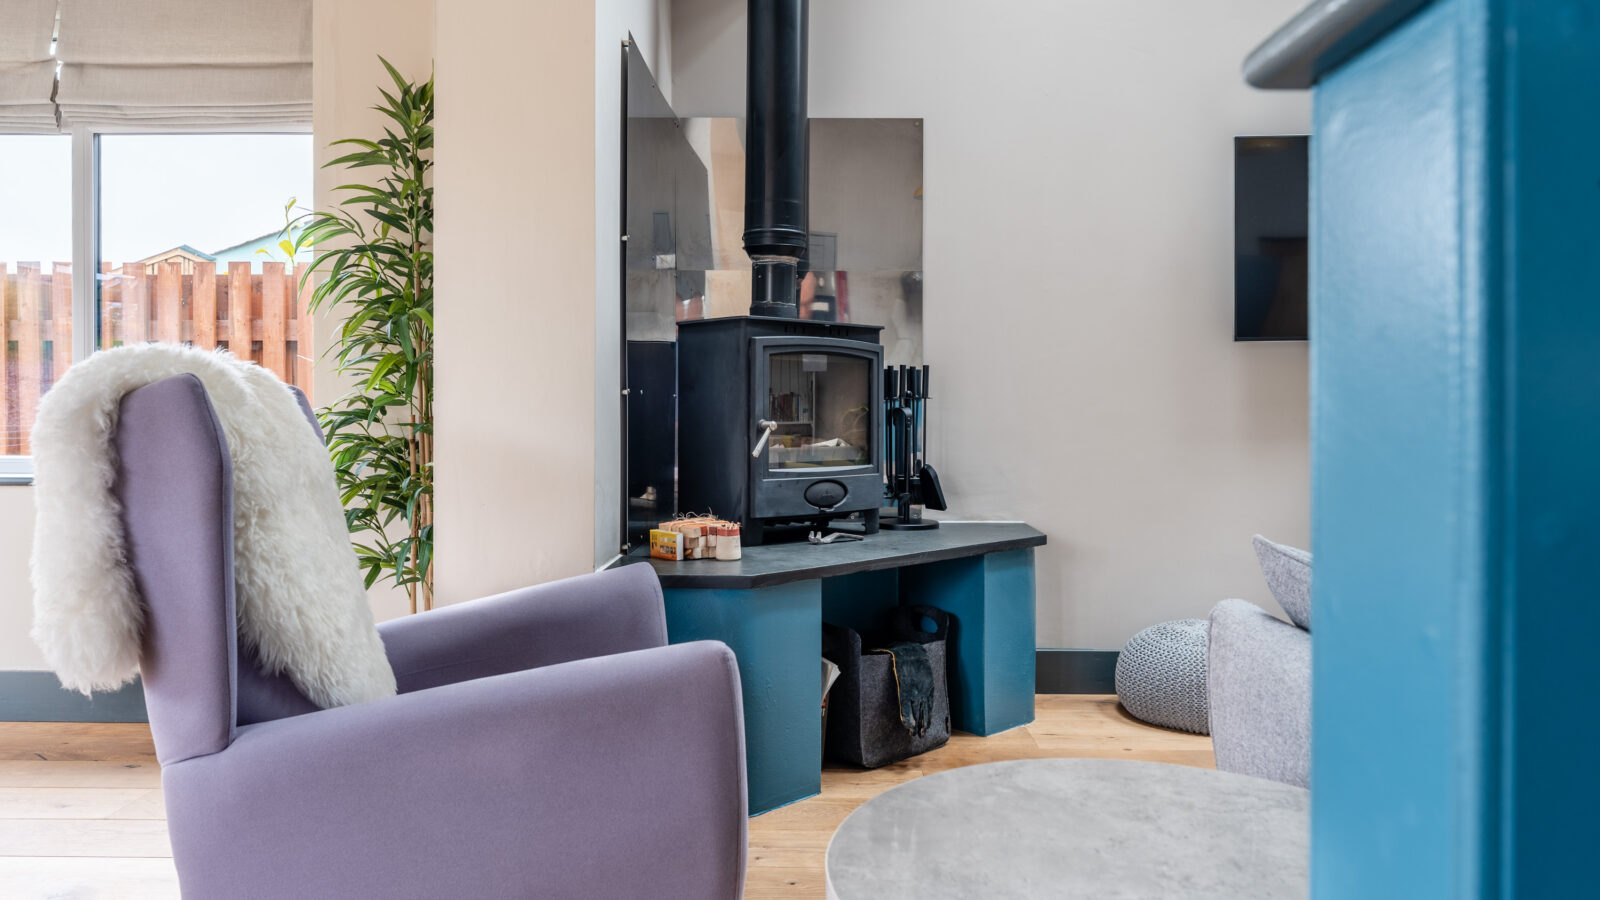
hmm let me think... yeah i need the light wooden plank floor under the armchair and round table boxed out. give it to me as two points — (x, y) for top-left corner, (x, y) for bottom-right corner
(0, 693), (1211, 900)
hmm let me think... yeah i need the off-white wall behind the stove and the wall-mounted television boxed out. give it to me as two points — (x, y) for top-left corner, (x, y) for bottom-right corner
(672, 0), (1310, 649)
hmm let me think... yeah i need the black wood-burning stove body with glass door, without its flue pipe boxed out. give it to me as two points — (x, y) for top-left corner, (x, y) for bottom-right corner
(678, 315), (883, 544)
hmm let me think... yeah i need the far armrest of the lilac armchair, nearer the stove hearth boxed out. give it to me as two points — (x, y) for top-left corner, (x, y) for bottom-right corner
(378, 565), (667, 693)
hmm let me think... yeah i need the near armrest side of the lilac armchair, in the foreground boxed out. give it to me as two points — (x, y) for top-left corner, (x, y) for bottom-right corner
(162, 641), (746, 900)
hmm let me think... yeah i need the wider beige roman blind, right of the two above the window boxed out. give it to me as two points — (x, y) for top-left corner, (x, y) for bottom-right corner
(54, 0), (312, 131)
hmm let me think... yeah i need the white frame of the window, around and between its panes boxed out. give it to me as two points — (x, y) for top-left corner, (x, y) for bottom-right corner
(0, 123), (315, 485)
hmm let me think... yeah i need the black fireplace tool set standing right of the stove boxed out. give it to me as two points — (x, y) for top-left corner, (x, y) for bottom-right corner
(880, 365), (947, 528)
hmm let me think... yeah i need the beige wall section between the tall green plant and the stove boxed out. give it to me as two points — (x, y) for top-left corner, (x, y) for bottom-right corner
(434, 0), (597, 604)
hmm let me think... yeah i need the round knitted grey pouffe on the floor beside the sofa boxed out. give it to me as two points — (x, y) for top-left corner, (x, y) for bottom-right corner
(1117, 618), (1211, 735)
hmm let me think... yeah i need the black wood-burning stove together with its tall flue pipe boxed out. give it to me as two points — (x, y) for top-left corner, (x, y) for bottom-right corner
(678, 0), (883, 544)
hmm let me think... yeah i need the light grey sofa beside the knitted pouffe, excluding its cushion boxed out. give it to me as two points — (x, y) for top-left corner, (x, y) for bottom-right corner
(1206, 601), (1310, 788)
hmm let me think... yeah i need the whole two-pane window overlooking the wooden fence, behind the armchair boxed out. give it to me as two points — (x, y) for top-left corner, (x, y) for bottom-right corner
(0, 130), (315, 480)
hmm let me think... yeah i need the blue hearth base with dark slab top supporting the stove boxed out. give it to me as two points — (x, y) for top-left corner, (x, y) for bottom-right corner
(658, 525), (1043, 815)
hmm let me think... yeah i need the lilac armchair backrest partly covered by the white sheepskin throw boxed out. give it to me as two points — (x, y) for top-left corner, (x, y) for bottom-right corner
(115, 375), (315, 764)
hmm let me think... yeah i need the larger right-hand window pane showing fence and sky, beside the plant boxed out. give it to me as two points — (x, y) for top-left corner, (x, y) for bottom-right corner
(98, 135), (312, 381)
